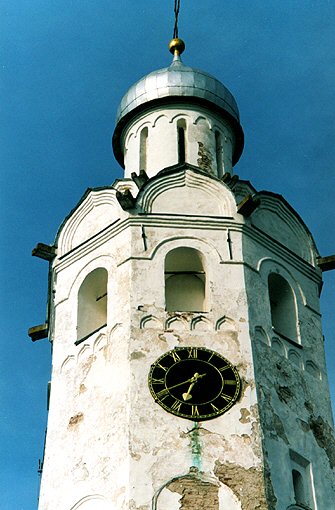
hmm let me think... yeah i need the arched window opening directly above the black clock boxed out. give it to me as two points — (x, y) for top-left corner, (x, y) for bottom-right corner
(165, 247), (206, 312)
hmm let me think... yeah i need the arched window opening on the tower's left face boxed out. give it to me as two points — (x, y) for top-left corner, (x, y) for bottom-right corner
(77, 267), (107, 340)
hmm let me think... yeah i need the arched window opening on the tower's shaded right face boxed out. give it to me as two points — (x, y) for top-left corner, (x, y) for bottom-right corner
(269, 273), (297, 342)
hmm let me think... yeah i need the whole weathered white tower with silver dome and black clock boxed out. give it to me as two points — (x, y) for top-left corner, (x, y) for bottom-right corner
(30, 39), (335, 510)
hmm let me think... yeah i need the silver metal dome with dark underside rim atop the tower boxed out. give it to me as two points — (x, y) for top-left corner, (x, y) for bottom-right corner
(113, 56), (244, 166)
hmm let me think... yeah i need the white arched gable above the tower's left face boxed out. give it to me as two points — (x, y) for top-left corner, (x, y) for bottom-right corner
(57, 188), (120, 256)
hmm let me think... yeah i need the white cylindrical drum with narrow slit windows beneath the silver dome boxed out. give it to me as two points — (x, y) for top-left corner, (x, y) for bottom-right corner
(121, 104), (235, 177)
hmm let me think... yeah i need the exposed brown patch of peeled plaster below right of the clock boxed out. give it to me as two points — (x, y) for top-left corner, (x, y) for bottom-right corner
(214, 461), (275, 510)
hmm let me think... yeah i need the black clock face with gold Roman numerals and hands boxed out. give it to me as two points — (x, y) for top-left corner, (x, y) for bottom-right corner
(149, 347), (241, 421)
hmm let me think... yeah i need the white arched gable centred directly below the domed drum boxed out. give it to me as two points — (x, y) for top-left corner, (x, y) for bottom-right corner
(139, 169), (236, 217)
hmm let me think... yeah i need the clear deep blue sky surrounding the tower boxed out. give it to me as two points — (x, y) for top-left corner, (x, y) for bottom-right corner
(0, 0), (335, 510)
